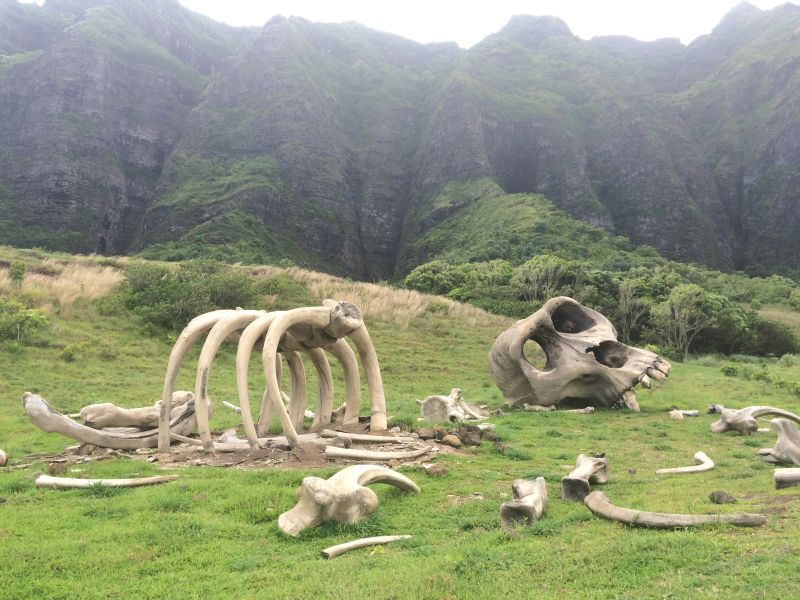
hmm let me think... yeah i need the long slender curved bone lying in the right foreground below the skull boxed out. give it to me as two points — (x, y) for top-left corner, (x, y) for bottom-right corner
(583, 491), (767, 529)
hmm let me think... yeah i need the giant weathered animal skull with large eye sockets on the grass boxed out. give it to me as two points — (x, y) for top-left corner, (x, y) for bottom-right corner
(489, 296), (670, 411)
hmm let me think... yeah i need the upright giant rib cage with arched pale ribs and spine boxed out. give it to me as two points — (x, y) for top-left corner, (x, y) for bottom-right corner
(158, 300), (386, 452)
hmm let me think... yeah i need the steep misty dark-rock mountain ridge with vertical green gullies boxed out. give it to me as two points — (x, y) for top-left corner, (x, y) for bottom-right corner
(0, 0), (800, 279)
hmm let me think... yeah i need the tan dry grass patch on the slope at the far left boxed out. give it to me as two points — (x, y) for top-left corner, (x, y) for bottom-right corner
(0, 259), (122, 316)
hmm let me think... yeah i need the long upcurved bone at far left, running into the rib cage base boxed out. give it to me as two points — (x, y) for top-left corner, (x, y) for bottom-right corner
(27, 392), (205, 450)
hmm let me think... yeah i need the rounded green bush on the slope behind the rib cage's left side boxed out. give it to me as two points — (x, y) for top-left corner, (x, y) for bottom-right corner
(120, 260), (263, 331)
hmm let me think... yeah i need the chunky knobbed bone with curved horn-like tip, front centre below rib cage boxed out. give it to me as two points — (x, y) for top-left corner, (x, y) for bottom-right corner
(278, 465), (419, 536)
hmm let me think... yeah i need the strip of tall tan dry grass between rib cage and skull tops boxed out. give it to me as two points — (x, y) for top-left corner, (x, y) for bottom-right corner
(259, 267), (507, 327)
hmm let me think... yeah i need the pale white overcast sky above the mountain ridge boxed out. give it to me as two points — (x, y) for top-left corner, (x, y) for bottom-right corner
(173, 0), (796, 48)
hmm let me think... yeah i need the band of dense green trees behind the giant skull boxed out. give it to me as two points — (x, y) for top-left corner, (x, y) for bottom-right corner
(405, 254), (800, 358)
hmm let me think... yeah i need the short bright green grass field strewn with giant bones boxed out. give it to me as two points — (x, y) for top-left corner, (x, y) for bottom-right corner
(0, 251), (800, 600)
